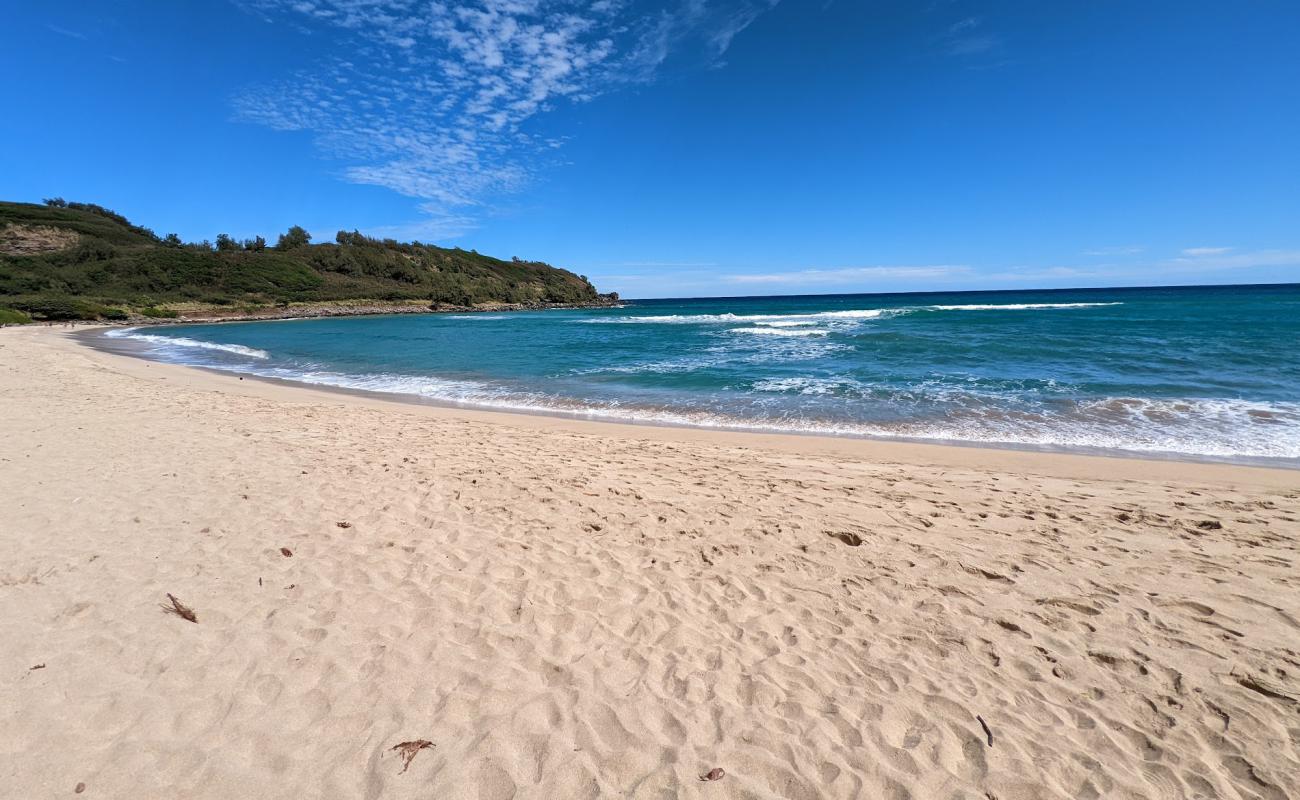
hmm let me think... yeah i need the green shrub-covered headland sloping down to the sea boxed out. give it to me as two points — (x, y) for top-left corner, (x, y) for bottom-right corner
(0, 200), (616, 321)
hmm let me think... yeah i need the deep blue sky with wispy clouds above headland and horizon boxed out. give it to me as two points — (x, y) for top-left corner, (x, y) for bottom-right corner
(0, 0), (1300, 297)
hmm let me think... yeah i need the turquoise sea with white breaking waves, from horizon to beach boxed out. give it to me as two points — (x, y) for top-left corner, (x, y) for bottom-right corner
(108, 285), (1300, 466)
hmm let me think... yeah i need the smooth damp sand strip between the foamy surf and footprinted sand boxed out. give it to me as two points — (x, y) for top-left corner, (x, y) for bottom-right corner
(65, 327), (1300, 487)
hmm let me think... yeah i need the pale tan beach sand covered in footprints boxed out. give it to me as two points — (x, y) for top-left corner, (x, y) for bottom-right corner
(0, 329), (1300, 800)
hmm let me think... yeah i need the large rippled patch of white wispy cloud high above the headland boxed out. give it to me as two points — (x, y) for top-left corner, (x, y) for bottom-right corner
(234, 0), (777, 238)
